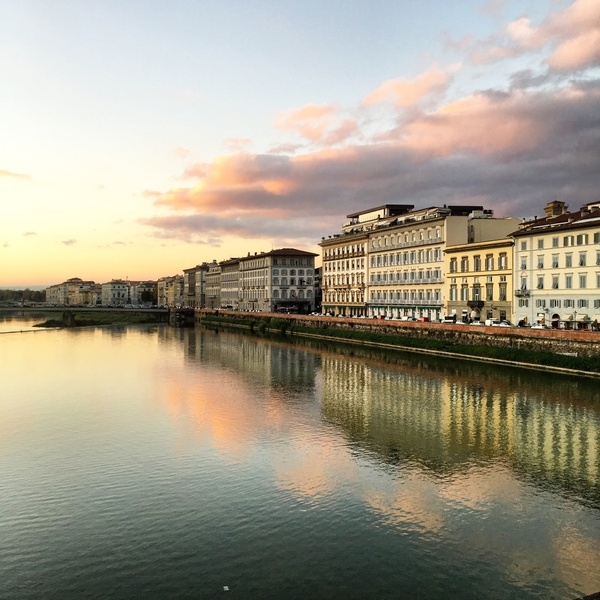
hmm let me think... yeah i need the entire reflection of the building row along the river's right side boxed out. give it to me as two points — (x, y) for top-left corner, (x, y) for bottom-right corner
(161, 328), (600, 502)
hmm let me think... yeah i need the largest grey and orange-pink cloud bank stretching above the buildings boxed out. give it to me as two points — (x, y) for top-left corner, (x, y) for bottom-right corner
(141, 75), (600, 240)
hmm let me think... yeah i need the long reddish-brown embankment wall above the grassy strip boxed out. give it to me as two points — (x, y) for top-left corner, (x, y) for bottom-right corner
(197, 310), (600, 358)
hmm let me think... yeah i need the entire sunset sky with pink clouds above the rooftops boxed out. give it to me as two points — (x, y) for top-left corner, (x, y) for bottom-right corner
(0, 0), (600, 287)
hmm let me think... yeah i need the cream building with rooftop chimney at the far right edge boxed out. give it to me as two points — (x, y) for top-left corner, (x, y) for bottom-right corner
(513, 200), (600, 329)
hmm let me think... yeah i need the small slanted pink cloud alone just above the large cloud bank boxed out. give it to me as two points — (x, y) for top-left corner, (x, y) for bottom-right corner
(364, 65), (452, 108)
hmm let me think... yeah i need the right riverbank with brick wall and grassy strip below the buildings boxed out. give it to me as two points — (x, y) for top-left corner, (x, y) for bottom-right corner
(197, 310), (600, 377)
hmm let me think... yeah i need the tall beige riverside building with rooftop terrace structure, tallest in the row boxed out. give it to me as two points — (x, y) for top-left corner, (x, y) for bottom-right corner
(319, 204), (515, 320)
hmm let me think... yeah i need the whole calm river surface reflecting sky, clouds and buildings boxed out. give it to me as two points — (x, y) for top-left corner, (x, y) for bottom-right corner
(0, 316), (600, 600)
